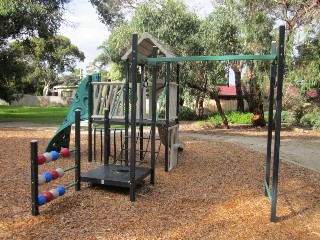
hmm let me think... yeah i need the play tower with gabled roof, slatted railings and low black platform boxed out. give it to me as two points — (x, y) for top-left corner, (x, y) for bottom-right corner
(81, 32), (183, 201)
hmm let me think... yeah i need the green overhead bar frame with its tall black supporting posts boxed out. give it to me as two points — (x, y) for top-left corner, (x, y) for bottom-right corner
(122, 26), (285, 222)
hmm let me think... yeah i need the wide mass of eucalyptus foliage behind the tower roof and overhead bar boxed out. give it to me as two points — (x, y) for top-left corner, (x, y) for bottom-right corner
(91, 0), (320, 127)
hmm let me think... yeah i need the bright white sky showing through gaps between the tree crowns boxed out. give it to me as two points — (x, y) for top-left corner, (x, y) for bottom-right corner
(59, 0), (211, 70)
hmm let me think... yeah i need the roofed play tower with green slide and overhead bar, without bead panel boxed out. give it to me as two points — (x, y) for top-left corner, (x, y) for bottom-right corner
(38, 26), (285, 222)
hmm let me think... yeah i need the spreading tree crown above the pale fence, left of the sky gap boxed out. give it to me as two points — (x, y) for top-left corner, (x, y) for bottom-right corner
(12, 36), (85, 96)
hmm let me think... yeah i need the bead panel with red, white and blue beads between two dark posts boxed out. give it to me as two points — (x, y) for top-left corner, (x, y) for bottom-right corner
(30, 110), (81, 216)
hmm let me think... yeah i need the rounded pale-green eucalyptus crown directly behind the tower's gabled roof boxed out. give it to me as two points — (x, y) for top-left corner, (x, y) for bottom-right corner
(97, 0), (200, 86)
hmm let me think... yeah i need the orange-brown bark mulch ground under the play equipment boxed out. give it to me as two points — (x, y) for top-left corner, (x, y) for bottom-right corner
(0, 126), (320, 240)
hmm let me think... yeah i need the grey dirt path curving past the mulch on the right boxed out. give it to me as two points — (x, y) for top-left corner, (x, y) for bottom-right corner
(180, 132), (320, 172)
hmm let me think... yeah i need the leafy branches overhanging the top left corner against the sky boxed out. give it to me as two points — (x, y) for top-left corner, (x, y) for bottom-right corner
(0, 0), (70, 48)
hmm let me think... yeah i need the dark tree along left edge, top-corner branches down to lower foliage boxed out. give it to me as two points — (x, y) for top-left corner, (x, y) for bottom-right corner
(0, 0), (70, 102)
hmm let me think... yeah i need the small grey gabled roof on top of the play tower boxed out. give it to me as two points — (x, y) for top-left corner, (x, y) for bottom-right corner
(121, 32), (176, 60)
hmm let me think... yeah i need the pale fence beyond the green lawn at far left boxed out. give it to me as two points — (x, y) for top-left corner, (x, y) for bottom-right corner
(11, 94), (73, 107)
